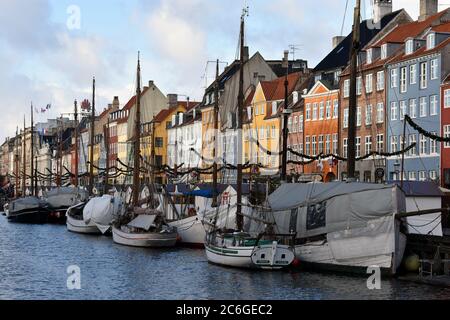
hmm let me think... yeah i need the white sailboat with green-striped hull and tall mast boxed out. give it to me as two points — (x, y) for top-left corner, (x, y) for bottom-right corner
(205, 9), (294, 270)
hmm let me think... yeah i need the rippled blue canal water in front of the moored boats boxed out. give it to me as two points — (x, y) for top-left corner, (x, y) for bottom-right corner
(0, 216), (450, 300)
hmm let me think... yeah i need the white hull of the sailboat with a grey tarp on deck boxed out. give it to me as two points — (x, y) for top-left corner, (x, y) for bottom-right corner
(112, 227), (177, 248)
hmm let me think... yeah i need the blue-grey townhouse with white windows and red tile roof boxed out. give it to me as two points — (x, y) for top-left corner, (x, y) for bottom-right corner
(385, 8), (450, 181)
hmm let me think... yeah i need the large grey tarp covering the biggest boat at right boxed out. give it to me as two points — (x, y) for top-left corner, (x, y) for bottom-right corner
(265, 182), (406, 238)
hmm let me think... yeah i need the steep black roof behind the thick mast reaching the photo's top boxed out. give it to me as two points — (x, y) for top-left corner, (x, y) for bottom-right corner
(314, 10), (403, 72)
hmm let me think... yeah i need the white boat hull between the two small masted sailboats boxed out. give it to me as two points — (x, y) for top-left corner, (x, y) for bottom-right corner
(169, 216), (206, 248)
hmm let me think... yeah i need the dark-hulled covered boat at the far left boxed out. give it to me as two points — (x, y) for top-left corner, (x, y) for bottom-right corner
(7, 197), (48, 224)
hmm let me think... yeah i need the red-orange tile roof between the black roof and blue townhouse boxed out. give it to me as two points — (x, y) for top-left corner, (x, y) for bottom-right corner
(372, 10), (447, 47)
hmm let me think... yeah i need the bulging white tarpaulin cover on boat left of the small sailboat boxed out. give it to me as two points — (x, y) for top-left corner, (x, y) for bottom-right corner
(83, 195), (123, 232)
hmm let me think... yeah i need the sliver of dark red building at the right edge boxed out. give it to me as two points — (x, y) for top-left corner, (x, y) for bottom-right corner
(440, 74), (450, 189)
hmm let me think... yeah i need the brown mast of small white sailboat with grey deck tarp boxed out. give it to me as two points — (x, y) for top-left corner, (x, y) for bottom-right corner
(133, 53), (141, 207)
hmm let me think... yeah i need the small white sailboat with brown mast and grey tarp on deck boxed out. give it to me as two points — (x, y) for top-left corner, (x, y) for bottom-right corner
(112, 55), (178, 247)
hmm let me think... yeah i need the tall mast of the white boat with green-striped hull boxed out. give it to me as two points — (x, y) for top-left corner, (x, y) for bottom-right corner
(236, 8), (248, 230)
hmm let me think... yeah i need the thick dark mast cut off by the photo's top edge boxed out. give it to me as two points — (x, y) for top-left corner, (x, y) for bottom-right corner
(347, 0), (361, 180)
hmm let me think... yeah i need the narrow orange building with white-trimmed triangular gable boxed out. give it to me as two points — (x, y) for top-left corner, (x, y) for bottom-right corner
(303, 80), (339, 182)
